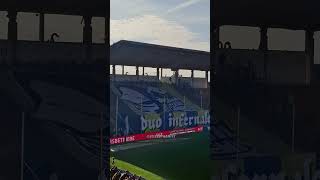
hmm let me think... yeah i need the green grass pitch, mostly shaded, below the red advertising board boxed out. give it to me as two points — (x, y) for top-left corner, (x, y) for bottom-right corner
(111, 132), (211, 180)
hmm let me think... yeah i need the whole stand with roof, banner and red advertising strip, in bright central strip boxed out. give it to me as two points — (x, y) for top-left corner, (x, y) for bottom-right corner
(110, 40), (210, 179)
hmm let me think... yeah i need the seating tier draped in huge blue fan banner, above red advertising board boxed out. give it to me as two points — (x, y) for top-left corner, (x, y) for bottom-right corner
(111, 75), (209, 136)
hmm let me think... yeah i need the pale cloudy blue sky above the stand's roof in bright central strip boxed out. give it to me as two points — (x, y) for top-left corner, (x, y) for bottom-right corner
(110, 0), (210, 51)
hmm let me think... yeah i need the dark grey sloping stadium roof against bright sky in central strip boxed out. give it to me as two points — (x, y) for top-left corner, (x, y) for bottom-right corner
(110, 40), (210, 71)
